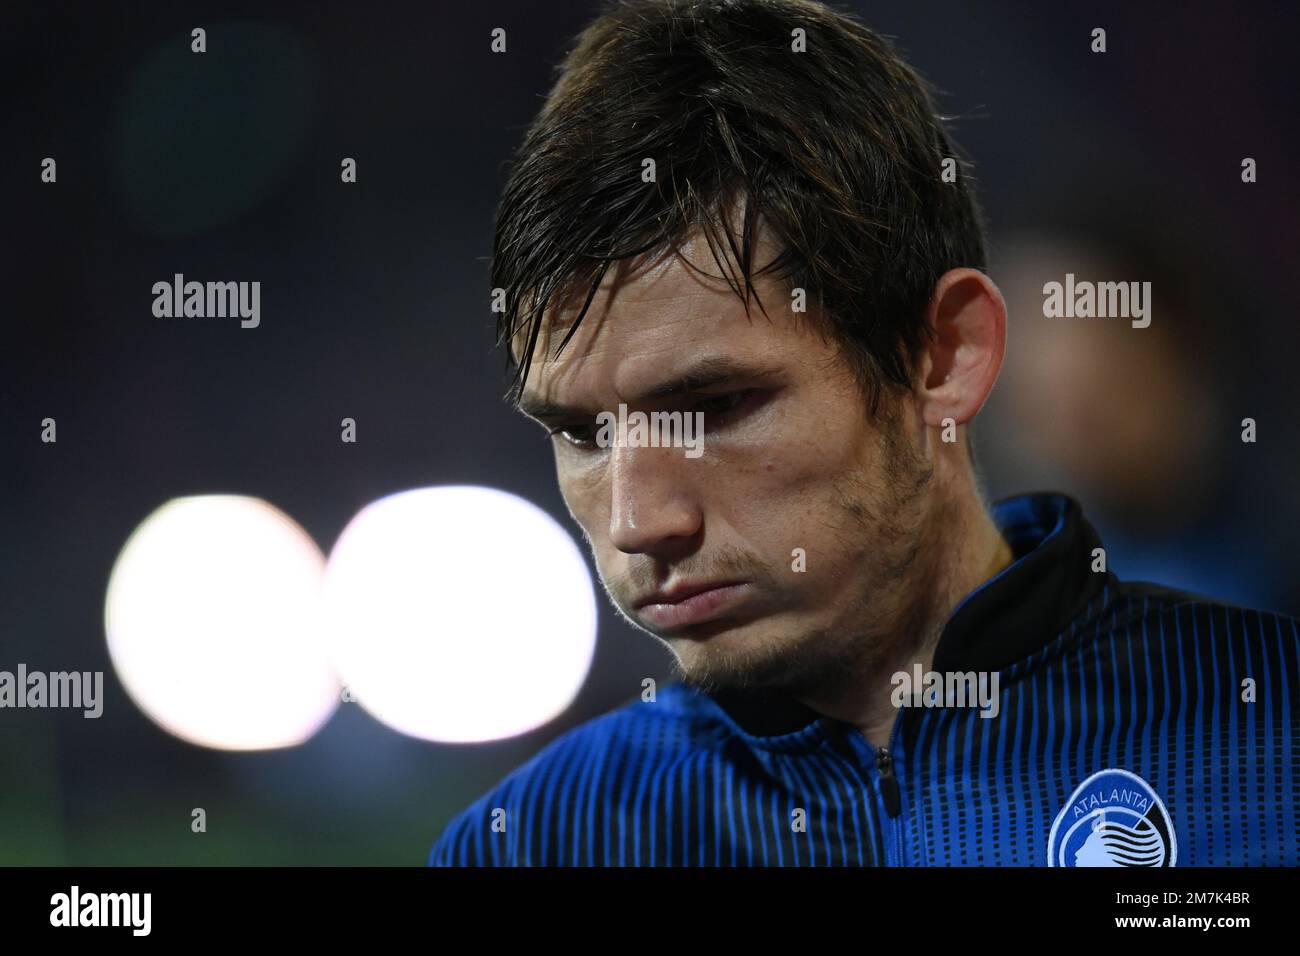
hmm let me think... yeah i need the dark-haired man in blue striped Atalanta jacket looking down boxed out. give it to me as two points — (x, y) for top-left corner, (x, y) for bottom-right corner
(429, 0), (1300, 866)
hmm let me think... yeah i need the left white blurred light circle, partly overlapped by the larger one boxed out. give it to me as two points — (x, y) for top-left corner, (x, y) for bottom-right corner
(104, 496), (341, 750)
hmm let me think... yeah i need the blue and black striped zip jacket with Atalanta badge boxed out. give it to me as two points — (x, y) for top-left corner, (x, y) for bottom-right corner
(428, 494), (1300, 866)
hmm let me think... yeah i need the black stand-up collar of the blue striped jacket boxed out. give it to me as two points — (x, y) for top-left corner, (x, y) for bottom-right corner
(706, 492), (1113, 750)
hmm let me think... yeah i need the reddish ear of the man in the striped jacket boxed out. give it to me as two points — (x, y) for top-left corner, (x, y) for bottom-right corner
(914, 268), (1006, 428)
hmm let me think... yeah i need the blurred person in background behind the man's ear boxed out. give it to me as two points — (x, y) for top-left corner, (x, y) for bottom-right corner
(976, 195), (1294, 607)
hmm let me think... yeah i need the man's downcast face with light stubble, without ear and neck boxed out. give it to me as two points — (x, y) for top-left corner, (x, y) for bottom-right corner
(521, 231), (936, 691)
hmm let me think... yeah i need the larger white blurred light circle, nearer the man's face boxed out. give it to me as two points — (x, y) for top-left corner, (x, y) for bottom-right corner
(324, 485), (597, 743)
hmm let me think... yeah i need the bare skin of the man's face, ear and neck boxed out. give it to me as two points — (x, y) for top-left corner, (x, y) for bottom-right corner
(520, 229), (1011, 741)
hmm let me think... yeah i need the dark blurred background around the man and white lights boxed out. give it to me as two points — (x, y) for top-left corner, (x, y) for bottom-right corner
(0, 1), (1300, 865)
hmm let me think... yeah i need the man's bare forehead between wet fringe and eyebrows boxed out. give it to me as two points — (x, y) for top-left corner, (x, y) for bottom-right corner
(514, 235), (798, 405)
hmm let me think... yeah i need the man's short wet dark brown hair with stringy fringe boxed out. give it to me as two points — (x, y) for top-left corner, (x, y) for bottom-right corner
(491, 0), (985, 414)
